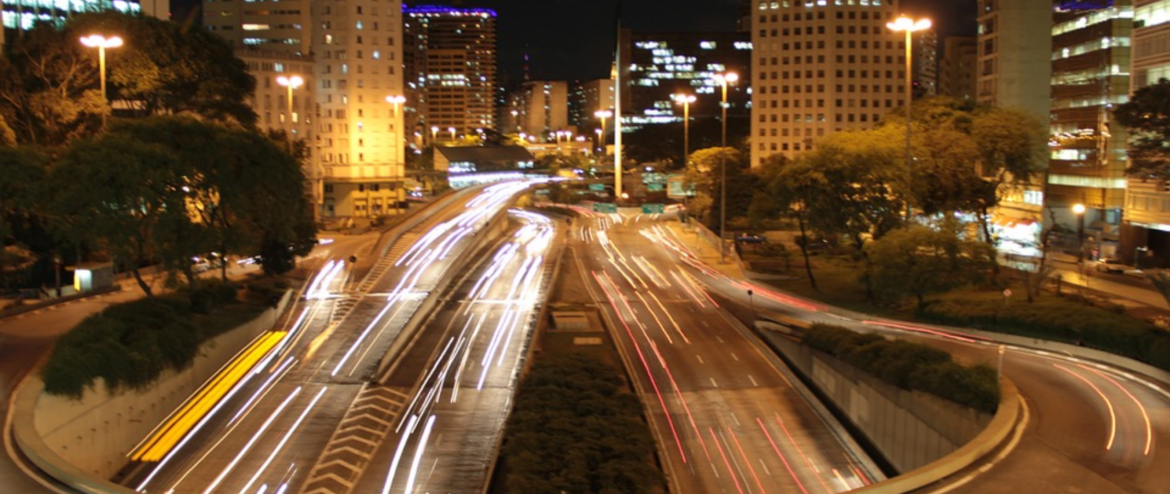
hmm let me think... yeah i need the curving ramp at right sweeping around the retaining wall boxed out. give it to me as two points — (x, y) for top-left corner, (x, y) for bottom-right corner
(645, 216), (1170, 494)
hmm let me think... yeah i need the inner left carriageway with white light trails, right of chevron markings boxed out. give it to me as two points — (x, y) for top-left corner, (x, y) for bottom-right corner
(353, 213), (559, 493)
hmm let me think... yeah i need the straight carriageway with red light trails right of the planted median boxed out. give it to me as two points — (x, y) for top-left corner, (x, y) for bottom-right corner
(571, 210), (882, 494)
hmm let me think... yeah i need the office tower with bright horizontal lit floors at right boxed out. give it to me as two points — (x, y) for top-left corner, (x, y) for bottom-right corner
(1045, 0), (1134, 255)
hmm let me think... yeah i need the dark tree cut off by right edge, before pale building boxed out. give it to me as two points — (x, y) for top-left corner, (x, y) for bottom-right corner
(1114, 78), (1170, 180)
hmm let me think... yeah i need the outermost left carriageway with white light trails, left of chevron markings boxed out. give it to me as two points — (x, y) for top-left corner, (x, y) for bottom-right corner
(121, 183), (527, 493)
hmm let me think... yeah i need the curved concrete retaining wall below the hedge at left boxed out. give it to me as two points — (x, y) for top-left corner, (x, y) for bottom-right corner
(13, 291), (291, 492)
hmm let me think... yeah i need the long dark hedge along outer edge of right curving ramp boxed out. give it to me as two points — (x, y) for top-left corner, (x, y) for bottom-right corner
(920, 297), (1170, 370)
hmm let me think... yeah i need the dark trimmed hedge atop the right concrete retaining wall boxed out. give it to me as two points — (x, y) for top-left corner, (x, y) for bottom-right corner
(804, 324), (999, 413)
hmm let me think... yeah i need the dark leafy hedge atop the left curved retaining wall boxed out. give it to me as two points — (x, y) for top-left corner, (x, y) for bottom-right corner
(43, 286), (262, 397)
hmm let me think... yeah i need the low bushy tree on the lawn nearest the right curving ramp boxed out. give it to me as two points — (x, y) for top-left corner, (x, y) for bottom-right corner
(866, 221), (995, 307)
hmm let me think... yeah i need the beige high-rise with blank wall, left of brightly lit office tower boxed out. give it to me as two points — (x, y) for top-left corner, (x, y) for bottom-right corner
(976, 0), (1052, 122)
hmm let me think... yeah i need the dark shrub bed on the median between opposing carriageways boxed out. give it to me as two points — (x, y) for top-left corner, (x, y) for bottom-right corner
(502, 354), (665, 494)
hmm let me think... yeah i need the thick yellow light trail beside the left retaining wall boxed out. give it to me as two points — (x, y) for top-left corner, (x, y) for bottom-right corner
(130, 331), (288, 461)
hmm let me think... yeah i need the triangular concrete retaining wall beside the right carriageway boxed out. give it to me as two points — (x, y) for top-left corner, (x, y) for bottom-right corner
(762, 331), (992, 473)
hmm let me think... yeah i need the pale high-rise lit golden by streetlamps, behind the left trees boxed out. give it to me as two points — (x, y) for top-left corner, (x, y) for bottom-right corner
(204, 0), (410, 218)
